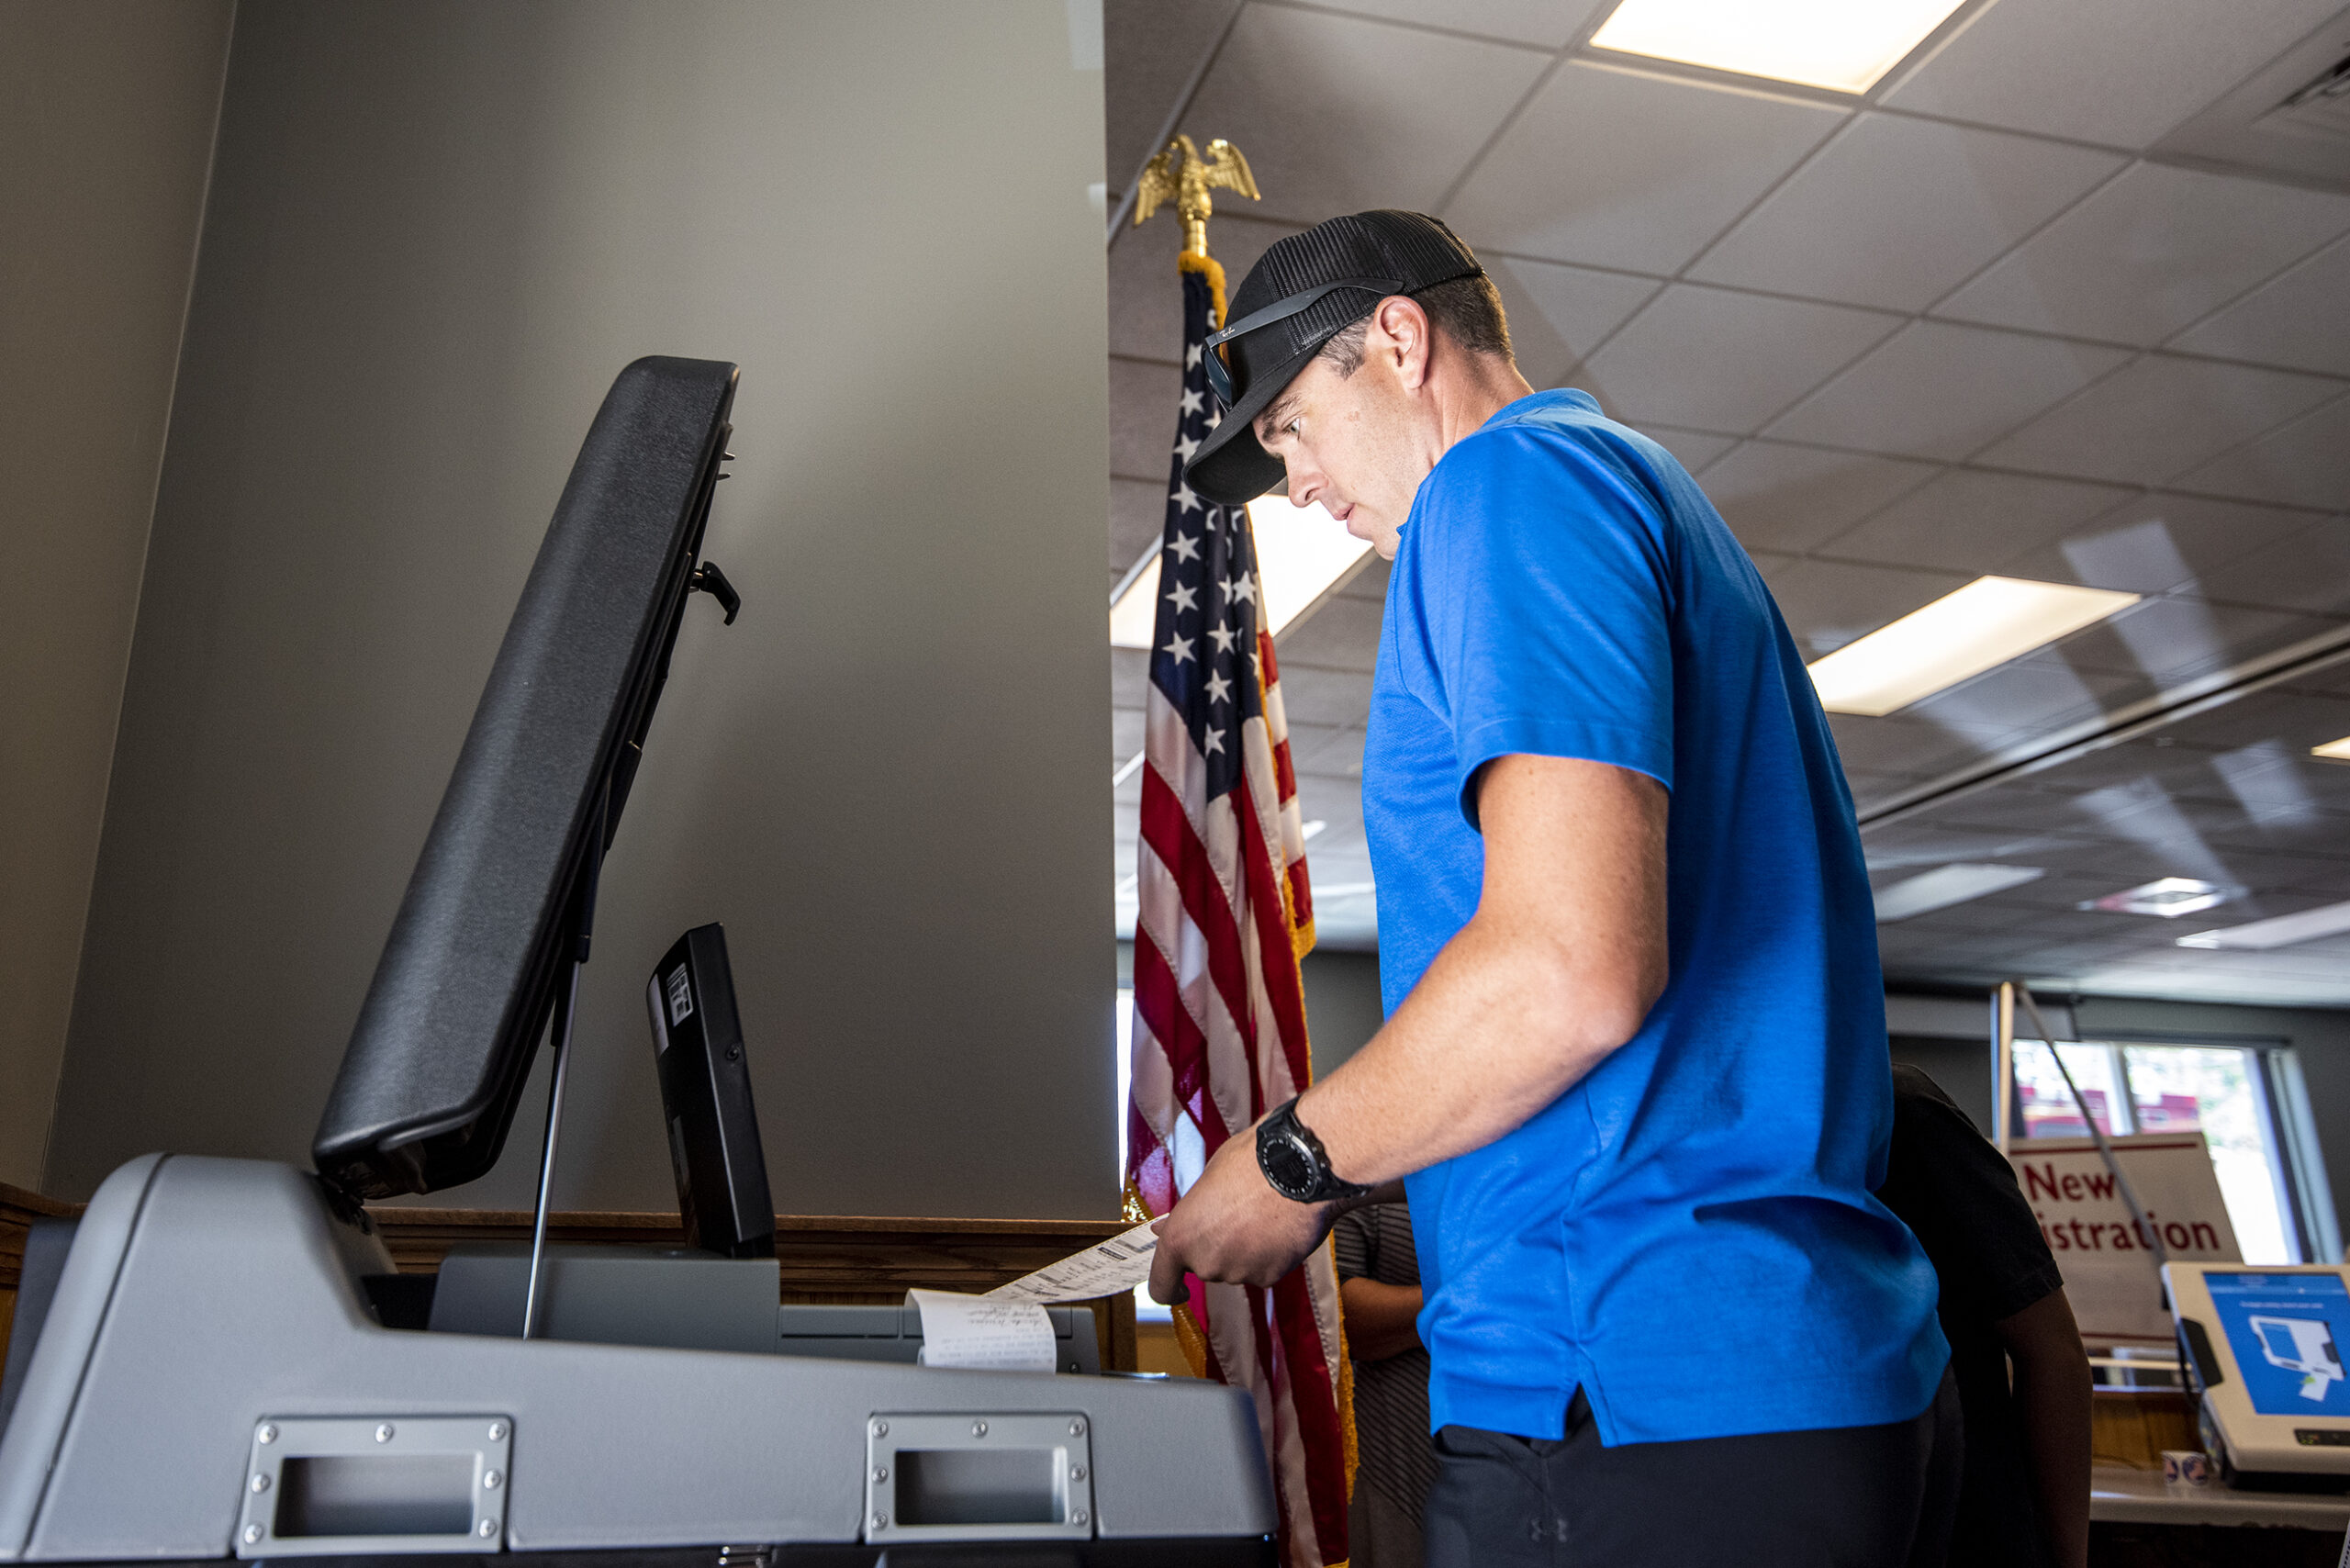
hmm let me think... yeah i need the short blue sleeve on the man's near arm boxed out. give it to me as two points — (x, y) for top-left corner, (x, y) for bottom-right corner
(1413, 425), (1673, 827)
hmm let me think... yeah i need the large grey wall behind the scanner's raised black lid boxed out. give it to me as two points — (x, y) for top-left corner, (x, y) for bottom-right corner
(47, 0), (1116, 1215)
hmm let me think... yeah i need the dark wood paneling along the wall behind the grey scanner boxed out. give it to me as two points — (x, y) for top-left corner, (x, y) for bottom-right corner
(0, 1182), (1135, 1371)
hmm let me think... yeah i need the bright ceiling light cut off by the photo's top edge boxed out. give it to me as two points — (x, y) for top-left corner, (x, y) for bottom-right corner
(1591, 0), (1960, 92)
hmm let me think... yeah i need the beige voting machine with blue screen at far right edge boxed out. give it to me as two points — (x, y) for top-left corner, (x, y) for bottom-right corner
(2162, 1262), (2350, 1490)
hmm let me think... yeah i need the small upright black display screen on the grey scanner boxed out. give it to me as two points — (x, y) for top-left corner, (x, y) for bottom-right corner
(643, 924), (776, 1258)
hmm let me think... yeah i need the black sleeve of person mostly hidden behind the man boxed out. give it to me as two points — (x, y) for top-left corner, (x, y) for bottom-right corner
(1880, 1070), (2064, 1326)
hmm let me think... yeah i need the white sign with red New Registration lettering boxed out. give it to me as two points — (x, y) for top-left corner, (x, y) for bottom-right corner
(2007, 1133), (2244, 1342)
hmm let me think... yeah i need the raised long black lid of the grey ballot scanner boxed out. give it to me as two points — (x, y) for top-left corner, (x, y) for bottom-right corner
(312, 357), (735, 1196)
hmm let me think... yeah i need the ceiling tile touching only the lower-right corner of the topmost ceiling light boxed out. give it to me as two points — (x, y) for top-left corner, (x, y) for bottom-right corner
(1690, 115), (2122, 310)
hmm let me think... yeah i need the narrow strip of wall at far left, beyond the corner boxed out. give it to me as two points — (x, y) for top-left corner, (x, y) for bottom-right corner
(0, 0), (232, 1187)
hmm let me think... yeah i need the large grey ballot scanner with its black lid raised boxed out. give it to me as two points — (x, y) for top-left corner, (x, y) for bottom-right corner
(0, 360), (1274, 1568)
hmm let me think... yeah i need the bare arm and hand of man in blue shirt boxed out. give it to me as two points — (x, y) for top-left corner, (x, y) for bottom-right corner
(1151, 755), (1669, 1300)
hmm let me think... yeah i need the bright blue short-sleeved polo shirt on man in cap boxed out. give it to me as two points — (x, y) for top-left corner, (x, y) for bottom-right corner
(1363, 393), (1951, 1446)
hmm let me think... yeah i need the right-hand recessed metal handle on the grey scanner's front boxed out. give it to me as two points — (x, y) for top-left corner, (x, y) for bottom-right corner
(865, 1410), (1092, 1542)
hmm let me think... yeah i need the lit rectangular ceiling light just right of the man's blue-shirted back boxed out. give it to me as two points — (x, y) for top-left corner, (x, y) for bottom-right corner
(1812, 576), (2139, 717)
